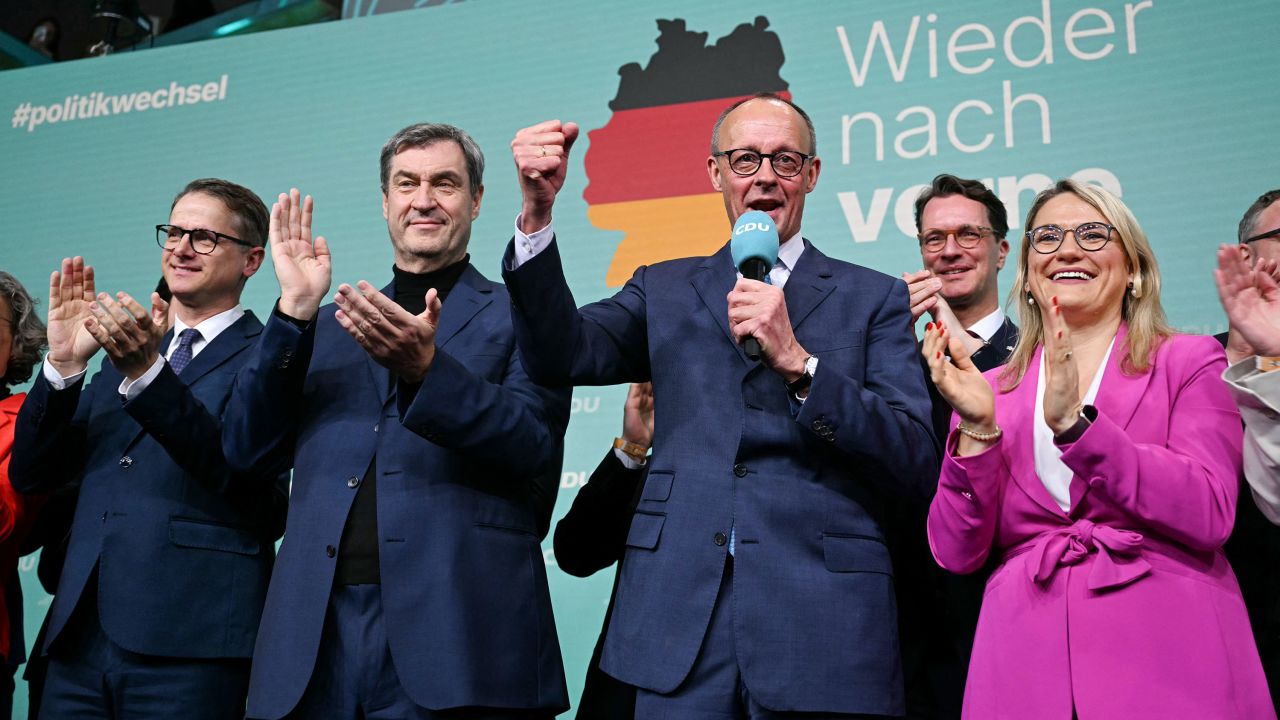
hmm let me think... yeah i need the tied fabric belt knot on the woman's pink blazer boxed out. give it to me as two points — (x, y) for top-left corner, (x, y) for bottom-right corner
(1028, 518), (1151, 591)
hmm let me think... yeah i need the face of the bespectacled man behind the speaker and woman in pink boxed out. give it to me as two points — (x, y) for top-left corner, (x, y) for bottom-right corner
(920, 195), (1009, 315)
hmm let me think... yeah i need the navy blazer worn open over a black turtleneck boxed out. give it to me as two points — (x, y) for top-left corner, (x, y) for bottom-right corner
(225, 266), (570, 717)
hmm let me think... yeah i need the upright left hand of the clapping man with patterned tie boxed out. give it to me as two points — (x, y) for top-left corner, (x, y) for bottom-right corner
(47, 255), (101, 378)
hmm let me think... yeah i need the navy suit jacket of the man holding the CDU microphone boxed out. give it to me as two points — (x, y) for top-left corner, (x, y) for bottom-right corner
(504, 241), (938, 715)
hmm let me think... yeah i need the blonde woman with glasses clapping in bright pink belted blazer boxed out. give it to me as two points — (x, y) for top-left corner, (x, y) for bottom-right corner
(923, 181), (1276, 720)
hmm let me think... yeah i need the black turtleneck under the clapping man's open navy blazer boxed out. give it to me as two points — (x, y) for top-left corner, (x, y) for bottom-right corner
(334, 255), (471, 585)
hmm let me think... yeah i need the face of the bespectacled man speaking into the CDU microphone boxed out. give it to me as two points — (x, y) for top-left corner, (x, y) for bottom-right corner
(707, 99), (820, 242)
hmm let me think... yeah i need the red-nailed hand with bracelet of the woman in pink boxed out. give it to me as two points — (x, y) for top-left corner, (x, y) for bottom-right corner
(920, 315), (997, 455)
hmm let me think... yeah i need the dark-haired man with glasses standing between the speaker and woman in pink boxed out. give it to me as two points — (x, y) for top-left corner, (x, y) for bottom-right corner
(891, 174), (1018, 720)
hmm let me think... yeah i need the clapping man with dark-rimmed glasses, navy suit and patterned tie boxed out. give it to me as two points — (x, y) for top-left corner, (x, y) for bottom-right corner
(9, 179), (288, 719)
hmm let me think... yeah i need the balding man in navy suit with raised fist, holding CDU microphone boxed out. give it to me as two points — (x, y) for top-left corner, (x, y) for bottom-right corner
(504, 95), (938, 720)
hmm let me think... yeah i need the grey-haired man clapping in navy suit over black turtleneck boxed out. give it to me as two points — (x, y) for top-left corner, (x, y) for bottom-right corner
(225, 124), (570, 720)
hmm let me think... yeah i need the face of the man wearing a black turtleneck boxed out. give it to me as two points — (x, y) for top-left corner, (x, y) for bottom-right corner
(383, 140), (484, 273)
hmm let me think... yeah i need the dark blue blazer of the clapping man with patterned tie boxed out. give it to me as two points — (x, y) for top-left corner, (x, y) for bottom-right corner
(9, 313), (288, 657)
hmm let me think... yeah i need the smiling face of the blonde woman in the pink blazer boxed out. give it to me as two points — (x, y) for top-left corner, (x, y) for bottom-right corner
(1023, 192), (1132, 327)
